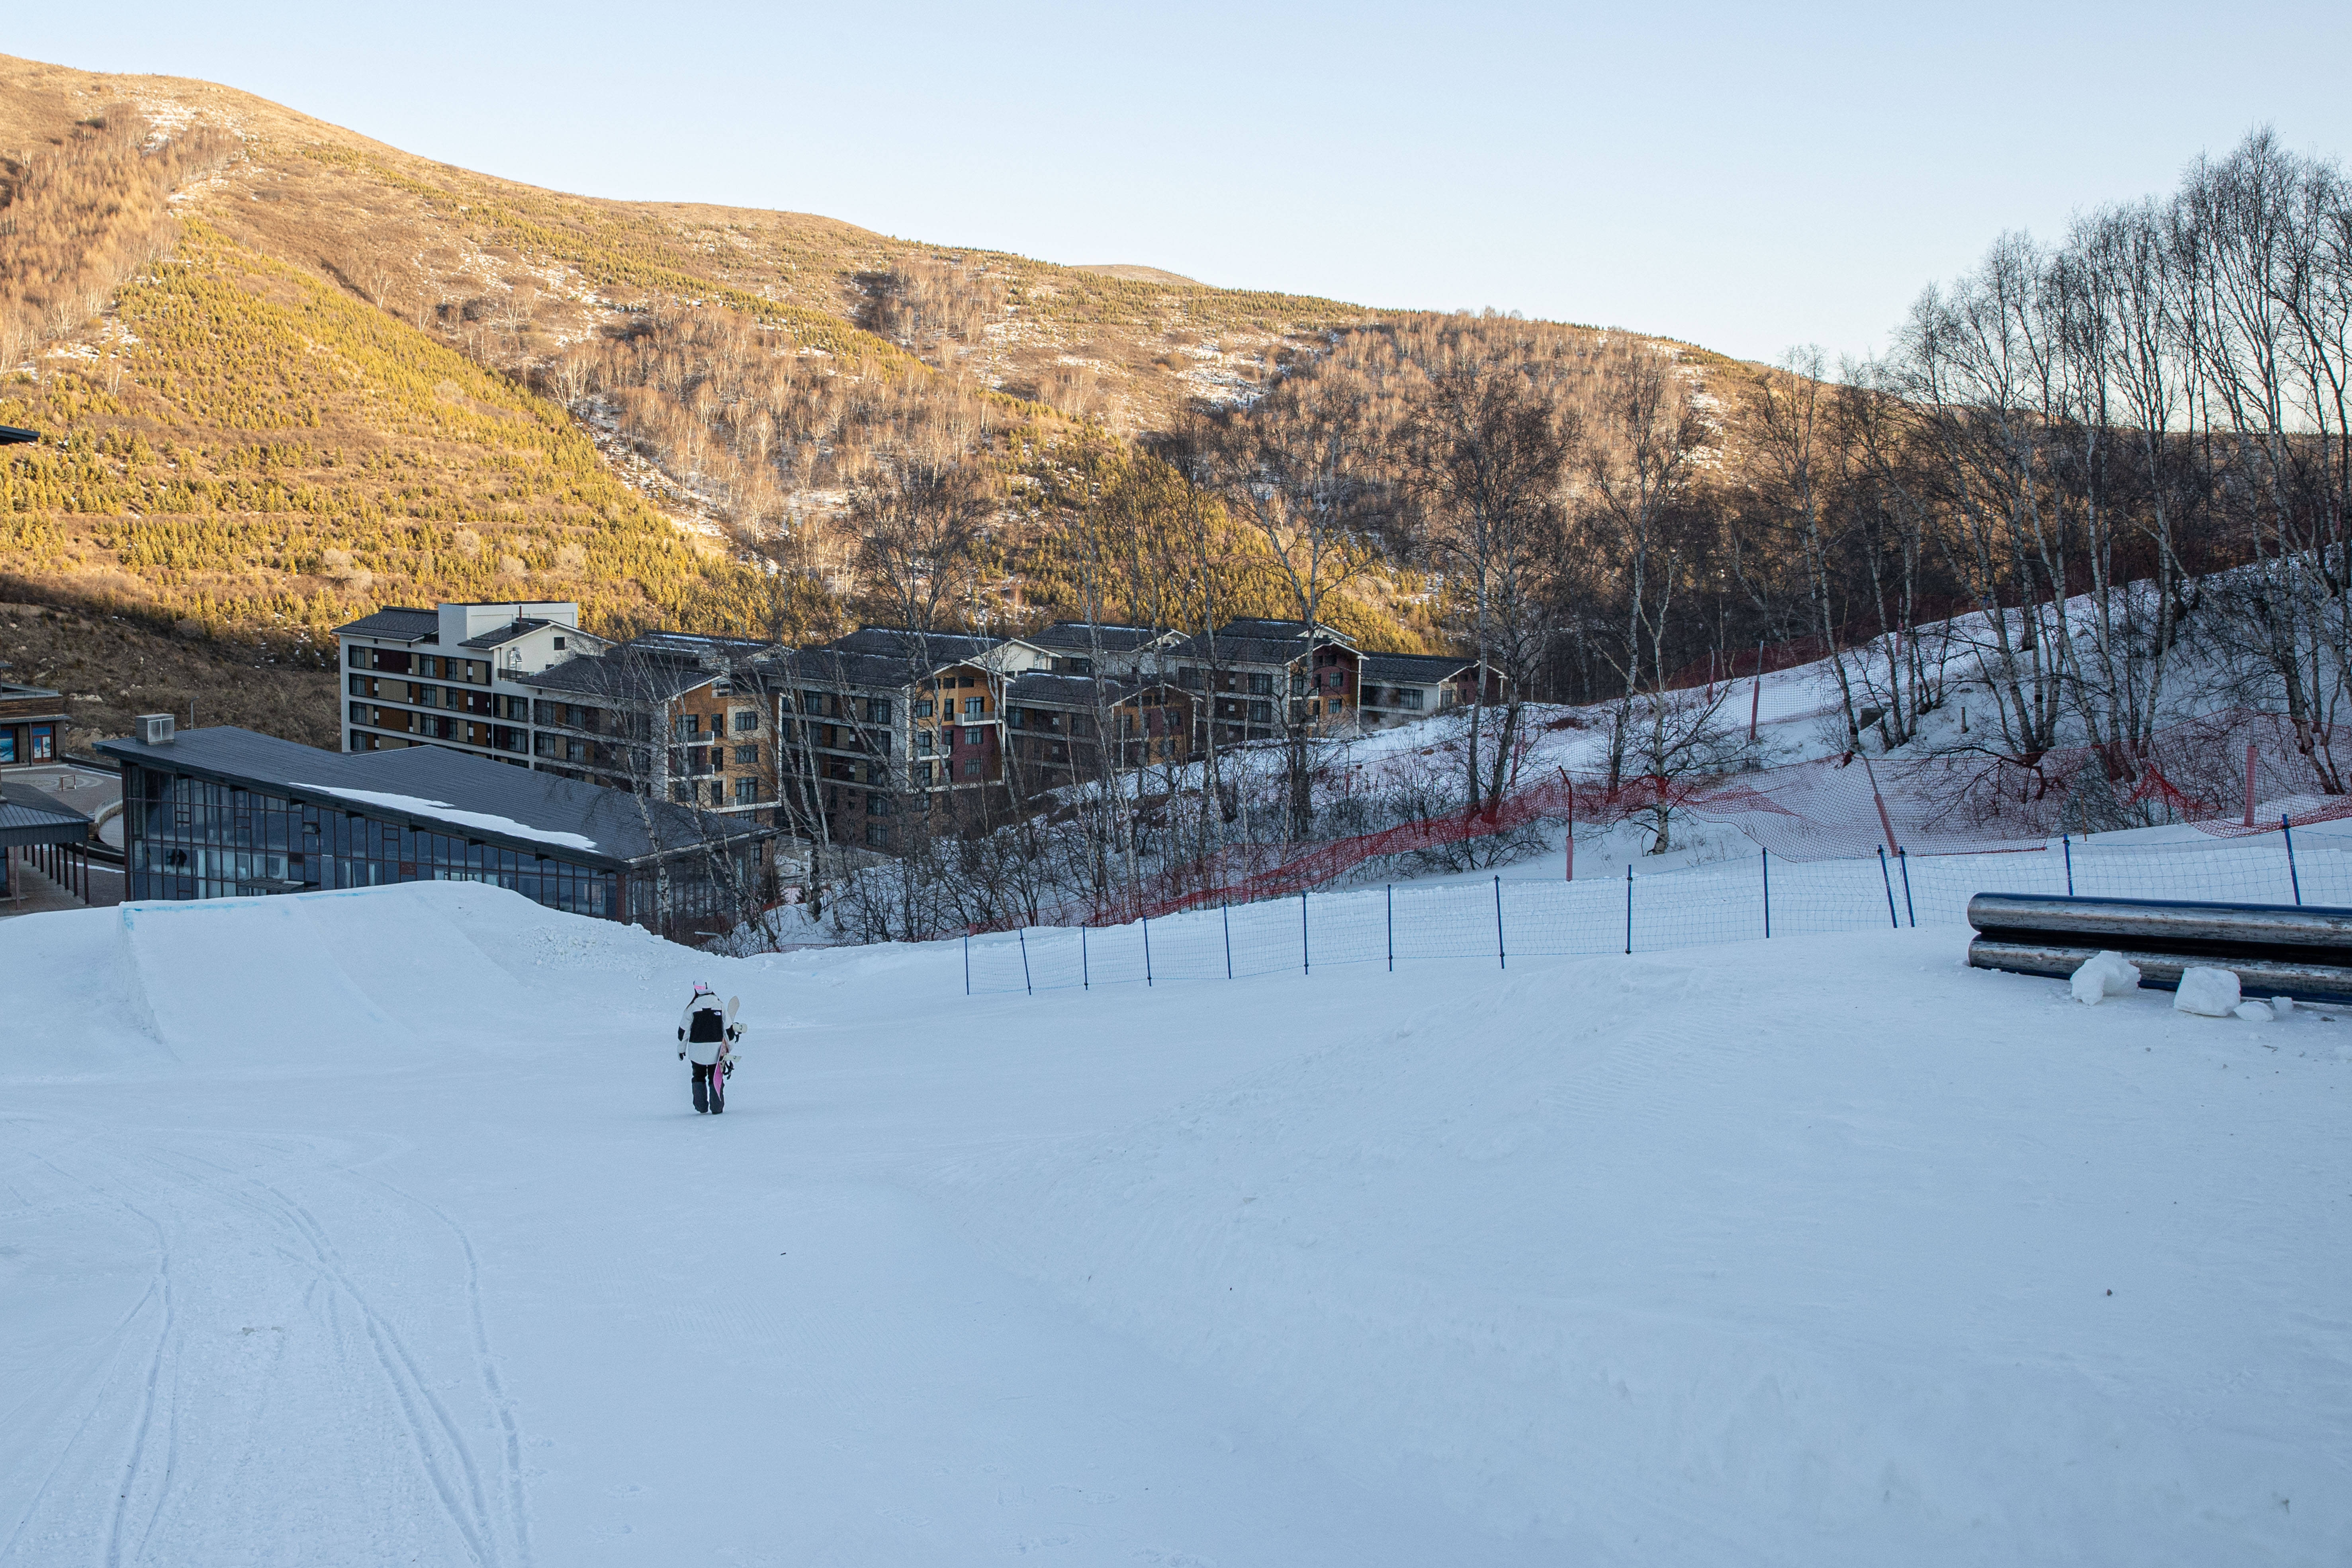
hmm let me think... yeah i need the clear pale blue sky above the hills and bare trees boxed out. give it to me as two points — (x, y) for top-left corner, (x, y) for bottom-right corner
(0, 0), (2352, 360)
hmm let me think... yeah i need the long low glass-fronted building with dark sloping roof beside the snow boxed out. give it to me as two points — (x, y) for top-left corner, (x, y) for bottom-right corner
(99, 715), (774, 938)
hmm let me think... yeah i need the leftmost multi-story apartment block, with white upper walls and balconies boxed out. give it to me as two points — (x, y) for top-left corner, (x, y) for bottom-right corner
(334, 599), (612, 766)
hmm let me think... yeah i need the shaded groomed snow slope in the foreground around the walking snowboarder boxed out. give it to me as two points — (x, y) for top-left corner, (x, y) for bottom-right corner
(0, 884), (2352, 1568)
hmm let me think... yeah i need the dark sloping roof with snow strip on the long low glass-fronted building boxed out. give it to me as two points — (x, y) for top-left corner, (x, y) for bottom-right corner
(99, 724), (774, 865)
